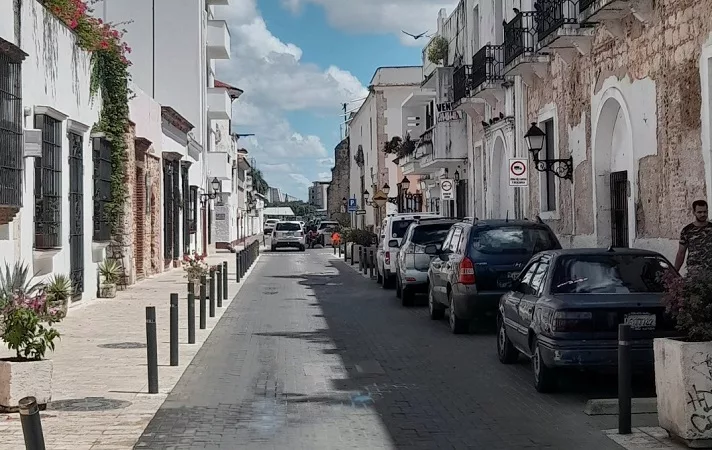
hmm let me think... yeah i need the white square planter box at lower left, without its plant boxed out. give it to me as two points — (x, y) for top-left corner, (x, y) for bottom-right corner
(0, 359), (53, 411)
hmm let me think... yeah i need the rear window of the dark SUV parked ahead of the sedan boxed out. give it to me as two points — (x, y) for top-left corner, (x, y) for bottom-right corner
(471, 226), (560, 255)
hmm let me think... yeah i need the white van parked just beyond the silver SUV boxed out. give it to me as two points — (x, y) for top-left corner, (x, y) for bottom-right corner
(376, 212), (440, 289)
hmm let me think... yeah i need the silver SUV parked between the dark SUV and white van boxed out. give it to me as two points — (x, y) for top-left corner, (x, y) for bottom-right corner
(395, 217), (458, 306)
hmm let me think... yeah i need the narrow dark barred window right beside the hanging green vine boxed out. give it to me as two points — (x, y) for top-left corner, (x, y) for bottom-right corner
(92, 137), (112, 242)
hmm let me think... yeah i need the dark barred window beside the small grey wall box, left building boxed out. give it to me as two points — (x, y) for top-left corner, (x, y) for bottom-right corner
(35, 115), (62, 249)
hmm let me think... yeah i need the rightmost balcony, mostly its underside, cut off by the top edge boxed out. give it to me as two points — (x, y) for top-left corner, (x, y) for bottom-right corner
(579, 0), (653, 39)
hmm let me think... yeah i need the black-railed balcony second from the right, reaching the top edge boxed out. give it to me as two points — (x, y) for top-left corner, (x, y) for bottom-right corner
(536, 0), (595, 64)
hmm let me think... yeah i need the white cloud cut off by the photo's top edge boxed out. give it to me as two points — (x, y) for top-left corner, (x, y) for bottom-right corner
(282, 0), (458, 47)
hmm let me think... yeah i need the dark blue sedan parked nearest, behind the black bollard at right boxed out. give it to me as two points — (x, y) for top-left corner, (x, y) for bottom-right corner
(497, 248), (675, 392)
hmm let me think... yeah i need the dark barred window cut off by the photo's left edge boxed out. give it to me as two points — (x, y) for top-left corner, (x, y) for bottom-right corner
(0, 52), (23, 208)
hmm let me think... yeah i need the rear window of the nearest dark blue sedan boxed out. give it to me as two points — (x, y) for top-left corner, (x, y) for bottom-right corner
(551, 255), (671, 294)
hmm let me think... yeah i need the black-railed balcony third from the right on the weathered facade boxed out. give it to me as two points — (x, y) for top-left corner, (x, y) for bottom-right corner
(503, 11), (550, 84)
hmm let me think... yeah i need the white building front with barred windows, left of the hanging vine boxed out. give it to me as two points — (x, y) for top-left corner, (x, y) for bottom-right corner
(0, 1), (101, 301)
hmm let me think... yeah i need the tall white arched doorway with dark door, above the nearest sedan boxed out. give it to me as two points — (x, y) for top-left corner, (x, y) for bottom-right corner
(593, 88), (637, 247)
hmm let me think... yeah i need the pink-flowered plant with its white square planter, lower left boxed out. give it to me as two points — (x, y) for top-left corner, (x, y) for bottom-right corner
(0, 264), (64, 412)
